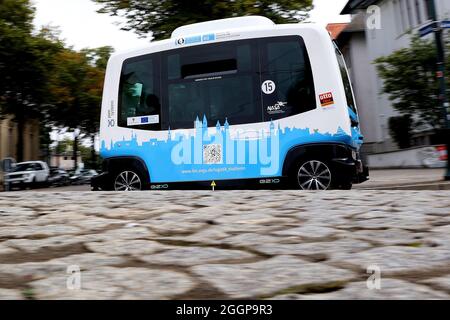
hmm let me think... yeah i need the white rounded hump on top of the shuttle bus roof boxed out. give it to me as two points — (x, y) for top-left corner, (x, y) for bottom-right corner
(172, 16), (275, 39)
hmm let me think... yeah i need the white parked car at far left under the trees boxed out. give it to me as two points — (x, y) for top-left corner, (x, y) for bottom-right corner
(5, 161), (50, 189)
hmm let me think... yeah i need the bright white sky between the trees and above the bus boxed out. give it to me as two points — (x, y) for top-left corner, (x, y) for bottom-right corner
(32, 0), (349, 51)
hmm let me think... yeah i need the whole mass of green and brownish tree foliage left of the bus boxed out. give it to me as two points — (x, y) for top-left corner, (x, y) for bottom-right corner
(0, 0), (113, 165)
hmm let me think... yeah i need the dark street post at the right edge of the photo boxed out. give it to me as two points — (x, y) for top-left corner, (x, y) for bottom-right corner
(427, 0), (450, 180)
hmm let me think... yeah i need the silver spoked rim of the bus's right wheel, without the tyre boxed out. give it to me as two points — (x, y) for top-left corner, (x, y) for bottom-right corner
(298, 160), (331, 190)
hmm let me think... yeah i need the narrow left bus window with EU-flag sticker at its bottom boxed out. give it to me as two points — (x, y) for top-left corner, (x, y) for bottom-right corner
(118, 55), (161, 130)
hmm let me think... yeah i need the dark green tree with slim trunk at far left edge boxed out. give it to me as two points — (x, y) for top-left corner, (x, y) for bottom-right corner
(0, 0), (62, 161)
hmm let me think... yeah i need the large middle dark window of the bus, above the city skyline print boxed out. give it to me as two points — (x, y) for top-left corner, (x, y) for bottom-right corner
(162, 40), (262, 129)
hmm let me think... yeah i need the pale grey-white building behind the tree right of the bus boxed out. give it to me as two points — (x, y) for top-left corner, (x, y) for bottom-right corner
(337, 0), (450, 153)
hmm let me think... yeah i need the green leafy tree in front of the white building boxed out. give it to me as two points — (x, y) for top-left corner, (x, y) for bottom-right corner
(375, 37), (450, 134)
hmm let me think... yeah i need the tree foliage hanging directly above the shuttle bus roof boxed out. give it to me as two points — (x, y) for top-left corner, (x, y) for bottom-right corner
(93, 0), (313, 39)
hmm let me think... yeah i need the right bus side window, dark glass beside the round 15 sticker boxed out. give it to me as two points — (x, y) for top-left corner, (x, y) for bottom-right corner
(260, 36), (316, 121)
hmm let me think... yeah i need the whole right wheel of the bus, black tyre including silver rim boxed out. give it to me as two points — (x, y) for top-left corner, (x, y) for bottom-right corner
(291, 159), (334, 190)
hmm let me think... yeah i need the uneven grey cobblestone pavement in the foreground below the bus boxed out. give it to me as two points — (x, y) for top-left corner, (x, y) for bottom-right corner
(0, 190), (450, 299)
